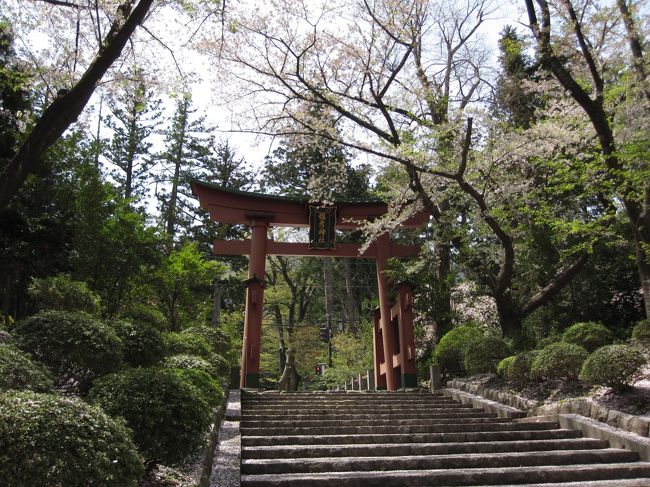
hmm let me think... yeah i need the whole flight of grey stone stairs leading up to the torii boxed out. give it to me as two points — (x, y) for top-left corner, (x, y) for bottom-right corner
(241, 392), (650, 487)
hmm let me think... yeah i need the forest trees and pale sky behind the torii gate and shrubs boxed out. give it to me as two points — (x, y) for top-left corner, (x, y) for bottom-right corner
(0, 0), (650, 384)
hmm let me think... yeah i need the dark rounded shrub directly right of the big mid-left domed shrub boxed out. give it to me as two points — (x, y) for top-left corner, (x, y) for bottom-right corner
(109, 320), (165, 367)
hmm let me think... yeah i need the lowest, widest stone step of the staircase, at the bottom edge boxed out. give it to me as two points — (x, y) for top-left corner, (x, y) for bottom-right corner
(241, 462), (650, 487)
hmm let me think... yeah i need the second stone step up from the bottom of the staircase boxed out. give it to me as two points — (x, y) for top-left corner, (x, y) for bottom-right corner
(241, 448), (639, 474)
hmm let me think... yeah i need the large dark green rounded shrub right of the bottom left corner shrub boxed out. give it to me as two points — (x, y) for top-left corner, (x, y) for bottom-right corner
(89, 367), (212, 466)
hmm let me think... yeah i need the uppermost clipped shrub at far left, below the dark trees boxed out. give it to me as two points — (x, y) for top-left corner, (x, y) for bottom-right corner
(28, 274), (100, 315)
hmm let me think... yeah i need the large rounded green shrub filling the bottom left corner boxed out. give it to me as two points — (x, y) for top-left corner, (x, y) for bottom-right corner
(0, 391), (144, 487)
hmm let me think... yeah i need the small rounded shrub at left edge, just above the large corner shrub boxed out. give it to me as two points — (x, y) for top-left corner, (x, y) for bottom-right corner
(0, 344), (54, 392)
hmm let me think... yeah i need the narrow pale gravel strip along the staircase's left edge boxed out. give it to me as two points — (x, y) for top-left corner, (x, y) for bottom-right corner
(210, 390), (241, 487)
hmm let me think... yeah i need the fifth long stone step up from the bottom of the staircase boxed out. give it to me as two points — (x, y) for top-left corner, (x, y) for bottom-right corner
(240, 418), (558, 436)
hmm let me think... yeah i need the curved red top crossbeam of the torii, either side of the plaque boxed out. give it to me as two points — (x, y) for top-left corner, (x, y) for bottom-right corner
(192, 180), (428, 230)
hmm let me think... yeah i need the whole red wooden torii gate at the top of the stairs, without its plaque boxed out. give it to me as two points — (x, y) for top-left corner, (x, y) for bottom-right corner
(192, 181), (428, 391)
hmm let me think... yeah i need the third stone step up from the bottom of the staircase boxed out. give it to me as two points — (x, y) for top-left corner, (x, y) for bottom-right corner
(241, 438), (609, 459)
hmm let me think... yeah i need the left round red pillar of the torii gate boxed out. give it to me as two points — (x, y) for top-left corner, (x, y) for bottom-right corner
(239, 218), (269, 389)
